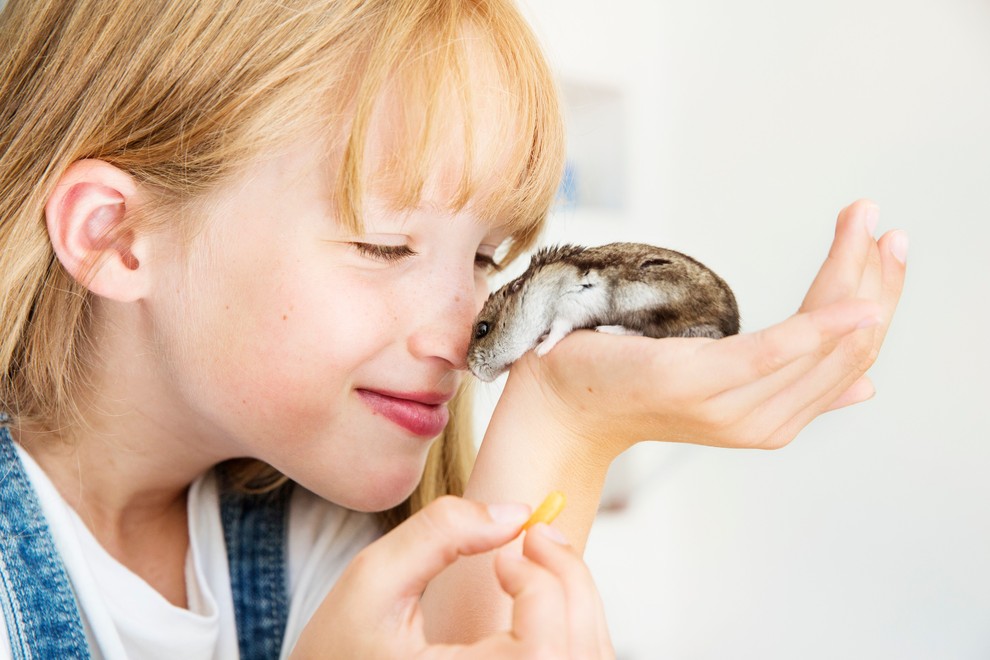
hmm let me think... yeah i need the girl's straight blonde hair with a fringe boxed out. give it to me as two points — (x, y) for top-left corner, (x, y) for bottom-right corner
(0, 0), (563, 517)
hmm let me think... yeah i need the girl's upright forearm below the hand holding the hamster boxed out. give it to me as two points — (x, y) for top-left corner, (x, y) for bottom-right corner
(423, 364), (611, 642)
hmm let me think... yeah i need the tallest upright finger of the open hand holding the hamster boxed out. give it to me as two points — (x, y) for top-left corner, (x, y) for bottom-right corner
(801, 200), (879, 311)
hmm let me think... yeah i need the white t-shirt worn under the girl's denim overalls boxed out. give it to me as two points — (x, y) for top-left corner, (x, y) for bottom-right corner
(0, 445), (379, 660)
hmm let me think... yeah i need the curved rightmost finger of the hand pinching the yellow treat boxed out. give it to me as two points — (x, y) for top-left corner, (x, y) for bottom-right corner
(523, 523), (611, 658)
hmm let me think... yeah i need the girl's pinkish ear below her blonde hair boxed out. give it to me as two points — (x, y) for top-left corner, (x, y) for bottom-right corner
(45, 160), (149, 302)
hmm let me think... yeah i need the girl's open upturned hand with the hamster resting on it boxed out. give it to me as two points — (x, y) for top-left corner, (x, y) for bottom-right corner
(503, 201), (907, 461)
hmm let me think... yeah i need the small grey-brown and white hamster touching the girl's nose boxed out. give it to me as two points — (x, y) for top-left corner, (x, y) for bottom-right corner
(467, 243), (739, 381)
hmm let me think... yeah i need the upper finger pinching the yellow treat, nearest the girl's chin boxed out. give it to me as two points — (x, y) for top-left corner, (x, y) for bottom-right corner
(354, 496), (530, 599)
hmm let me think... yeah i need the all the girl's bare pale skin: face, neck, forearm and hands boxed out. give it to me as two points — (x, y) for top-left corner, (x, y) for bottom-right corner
(18, 94), (906, 657)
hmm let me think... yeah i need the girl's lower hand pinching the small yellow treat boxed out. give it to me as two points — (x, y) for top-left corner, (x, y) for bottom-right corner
(292, 497), (613, 659)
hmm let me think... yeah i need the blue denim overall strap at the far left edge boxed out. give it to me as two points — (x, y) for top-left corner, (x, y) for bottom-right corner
(0, 420), (90, 660)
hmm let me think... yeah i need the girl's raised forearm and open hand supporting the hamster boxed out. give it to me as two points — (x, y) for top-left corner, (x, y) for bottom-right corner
(427, 200), (907, 640)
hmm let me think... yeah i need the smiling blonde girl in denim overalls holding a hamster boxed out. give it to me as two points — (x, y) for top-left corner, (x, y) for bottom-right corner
(0, 0), (905, 658)
